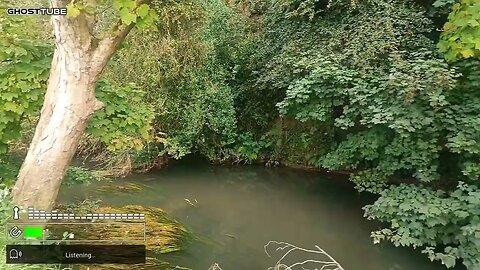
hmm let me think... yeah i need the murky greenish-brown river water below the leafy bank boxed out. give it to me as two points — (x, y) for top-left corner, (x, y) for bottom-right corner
(60, 161), (450, 270)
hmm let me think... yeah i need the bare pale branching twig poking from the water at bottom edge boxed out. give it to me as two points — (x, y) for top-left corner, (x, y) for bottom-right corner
(263, 241), (344, 270)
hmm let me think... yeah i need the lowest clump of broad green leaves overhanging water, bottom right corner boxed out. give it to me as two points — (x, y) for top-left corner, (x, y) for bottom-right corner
(366, 183), (480, 269)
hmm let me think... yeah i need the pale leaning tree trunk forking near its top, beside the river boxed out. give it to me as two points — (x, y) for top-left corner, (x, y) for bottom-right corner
(12, 0), (135, 210)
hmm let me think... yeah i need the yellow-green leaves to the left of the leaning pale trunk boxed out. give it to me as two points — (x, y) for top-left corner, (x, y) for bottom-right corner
(0, 9), (53, 154)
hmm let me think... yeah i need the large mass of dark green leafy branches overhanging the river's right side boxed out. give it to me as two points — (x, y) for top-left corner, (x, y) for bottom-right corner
(231, 1), (480, 269)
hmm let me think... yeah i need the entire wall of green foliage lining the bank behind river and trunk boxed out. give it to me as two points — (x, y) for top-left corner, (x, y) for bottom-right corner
(0, 0), (480, 270)
